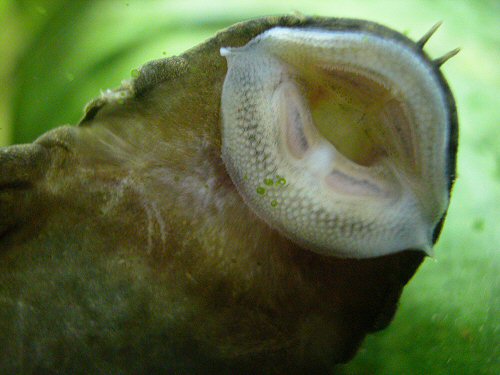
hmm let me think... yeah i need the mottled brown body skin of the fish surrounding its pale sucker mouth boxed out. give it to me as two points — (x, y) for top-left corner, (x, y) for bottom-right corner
(0, 17), (456, 374)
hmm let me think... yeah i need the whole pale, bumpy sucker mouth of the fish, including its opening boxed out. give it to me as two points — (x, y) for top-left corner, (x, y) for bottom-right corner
(221, 28), (450, 258)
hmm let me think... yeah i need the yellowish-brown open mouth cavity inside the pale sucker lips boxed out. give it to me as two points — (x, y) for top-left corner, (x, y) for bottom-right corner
(298, 67), (414, 172)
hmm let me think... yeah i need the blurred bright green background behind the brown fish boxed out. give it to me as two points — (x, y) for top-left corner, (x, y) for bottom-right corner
(0, 0), (500, 374)
